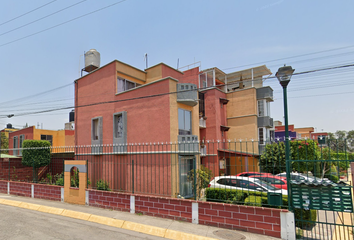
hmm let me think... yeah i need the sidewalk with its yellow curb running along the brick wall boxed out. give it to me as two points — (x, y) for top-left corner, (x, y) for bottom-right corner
(0, 194), (277, 240)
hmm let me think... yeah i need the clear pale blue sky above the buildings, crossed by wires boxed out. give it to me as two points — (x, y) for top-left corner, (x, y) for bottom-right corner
(0, 0), (354, 132)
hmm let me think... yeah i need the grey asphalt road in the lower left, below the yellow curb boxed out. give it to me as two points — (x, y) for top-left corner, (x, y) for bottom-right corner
(0, 205), (163, 240)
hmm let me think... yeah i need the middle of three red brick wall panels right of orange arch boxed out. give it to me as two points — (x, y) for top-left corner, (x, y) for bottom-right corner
(135, 195), (192, 222)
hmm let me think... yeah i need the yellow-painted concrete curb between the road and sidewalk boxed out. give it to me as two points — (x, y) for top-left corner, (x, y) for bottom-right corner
(0, 199), (216, 240)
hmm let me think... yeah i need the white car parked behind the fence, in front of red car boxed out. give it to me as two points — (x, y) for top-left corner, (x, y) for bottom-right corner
(208, 176), (288, 195)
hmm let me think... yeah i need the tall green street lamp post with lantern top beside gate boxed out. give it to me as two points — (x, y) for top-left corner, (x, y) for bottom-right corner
(275, 65), (295, 211)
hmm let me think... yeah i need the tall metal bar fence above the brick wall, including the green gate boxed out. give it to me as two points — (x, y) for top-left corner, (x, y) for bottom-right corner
(0, 139), (354, 239)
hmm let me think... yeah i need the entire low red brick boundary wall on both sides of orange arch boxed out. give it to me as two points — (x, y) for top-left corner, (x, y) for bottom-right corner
(0, 184), (288, 238)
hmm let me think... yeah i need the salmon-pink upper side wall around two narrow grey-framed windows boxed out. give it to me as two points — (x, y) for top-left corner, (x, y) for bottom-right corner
(75, 62), (176, 145)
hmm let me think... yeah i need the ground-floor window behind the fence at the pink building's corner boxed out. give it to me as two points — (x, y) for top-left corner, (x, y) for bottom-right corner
(179, 157), (195, 197)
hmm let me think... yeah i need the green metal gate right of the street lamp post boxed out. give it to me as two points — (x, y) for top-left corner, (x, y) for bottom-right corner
(287, 140), (354, 240)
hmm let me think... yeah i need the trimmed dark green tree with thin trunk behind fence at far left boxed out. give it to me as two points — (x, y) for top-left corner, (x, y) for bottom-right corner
(22, 140), (50, 182)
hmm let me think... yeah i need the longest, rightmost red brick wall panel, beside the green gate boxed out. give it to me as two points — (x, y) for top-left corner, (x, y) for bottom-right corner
(198, 202), (287, 238)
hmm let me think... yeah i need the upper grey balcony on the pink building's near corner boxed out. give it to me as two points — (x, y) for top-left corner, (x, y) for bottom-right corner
(177, 83), (198, 107)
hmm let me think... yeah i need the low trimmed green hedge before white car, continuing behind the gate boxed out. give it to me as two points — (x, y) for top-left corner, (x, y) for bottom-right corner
(206, 188), (317, 229)
